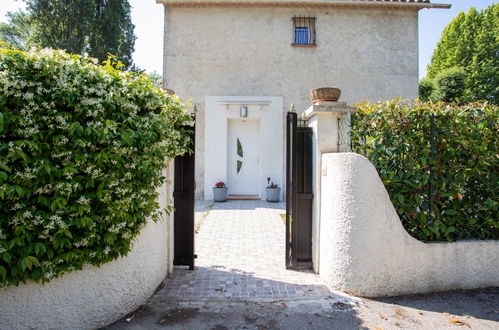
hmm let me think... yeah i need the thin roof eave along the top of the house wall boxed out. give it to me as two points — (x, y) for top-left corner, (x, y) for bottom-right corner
(156, 0), (452, 9)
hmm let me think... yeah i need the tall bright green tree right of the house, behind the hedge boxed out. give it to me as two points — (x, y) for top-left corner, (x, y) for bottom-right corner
(427, 4), (499, 103)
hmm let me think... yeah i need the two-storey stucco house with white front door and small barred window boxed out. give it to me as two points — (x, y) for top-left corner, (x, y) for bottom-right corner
(156, 0), (448, 199)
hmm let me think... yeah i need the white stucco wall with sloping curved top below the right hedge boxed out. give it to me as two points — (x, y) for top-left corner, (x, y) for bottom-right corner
(320, 153), (499, 297)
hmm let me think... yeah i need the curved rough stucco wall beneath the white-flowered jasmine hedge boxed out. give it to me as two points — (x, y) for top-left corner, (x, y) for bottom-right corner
(0, 162), (173, 329)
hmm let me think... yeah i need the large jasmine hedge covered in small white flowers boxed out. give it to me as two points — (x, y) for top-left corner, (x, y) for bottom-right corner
(0, 44), (190, 287)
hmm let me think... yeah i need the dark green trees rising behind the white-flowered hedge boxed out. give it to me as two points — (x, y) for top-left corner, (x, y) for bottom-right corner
(0, 0), (136, 68)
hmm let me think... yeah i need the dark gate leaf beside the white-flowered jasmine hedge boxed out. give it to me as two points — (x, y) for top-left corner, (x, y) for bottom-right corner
(173, 122), (196, 270)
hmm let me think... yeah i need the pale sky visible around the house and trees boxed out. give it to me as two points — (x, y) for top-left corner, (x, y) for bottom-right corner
(0, 0), (497, 78)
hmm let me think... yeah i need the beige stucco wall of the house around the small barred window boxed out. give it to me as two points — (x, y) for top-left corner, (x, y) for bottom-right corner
(164, 6), (418, 198)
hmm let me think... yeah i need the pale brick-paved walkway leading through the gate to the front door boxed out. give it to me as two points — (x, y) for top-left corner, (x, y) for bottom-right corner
(161, 200), (331, 299)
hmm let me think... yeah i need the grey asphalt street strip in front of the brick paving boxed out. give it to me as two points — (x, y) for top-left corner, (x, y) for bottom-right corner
(106, 282), (499, 330)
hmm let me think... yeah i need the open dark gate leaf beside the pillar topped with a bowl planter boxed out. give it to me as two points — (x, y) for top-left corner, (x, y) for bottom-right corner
(286, 112), (314, 269)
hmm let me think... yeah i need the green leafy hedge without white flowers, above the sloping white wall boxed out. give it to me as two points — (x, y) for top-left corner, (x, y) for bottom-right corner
(351, 101), (499, 241)
